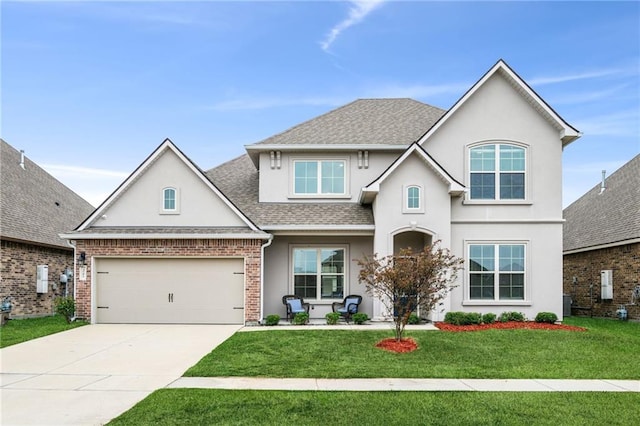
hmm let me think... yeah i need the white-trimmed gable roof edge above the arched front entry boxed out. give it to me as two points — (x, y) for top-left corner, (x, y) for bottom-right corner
(359, 142), (465, 204)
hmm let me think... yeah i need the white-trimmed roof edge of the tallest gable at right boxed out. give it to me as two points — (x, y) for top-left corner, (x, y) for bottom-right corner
(418, 59), (581, 146)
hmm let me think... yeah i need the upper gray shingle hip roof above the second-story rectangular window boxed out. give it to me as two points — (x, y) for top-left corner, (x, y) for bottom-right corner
(250, 98), (445, 146)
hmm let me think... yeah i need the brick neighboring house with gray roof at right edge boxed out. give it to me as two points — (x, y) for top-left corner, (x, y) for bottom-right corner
(563, 155), (640, 318)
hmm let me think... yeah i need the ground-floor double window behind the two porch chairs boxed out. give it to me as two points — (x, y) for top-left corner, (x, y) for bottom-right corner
(293, 247), (346, 300)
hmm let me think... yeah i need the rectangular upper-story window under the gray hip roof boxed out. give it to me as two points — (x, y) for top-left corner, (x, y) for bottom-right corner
(293, 160), (346, 195)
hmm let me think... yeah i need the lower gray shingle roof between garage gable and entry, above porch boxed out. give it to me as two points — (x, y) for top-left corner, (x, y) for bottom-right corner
(206, 155), (373, 227)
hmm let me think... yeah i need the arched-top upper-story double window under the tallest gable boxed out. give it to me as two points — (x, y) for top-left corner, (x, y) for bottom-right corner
(469, 144), (526, 200)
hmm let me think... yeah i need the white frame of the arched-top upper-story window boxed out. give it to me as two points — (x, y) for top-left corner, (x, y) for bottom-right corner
(464, 140), (532, 205)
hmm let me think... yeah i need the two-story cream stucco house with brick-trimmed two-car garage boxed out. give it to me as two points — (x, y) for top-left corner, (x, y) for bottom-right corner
(65, 61), (580, 324)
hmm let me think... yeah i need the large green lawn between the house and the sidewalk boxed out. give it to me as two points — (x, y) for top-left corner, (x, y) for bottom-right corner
(185, 318), (640, 380)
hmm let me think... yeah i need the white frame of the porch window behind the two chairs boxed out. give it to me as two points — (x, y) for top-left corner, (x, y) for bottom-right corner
(289, 244), (350, 304)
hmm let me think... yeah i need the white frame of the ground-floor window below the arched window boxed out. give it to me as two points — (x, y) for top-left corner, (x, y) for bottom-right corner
(462, 240), (531, 306)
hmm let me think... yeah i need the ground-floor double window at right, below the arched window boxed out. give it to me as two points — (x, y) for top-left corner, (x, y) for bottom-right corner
(469, 244), (526, 300)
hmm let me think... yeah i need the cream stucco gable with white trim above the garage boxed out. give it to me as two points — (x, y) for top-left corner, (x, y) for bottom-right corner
(77, 139), (258, 231)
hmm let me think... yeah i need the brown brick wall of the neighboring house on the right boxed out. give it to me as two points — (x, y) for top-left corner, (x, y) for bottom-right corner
(563, 243), (640, 319)
